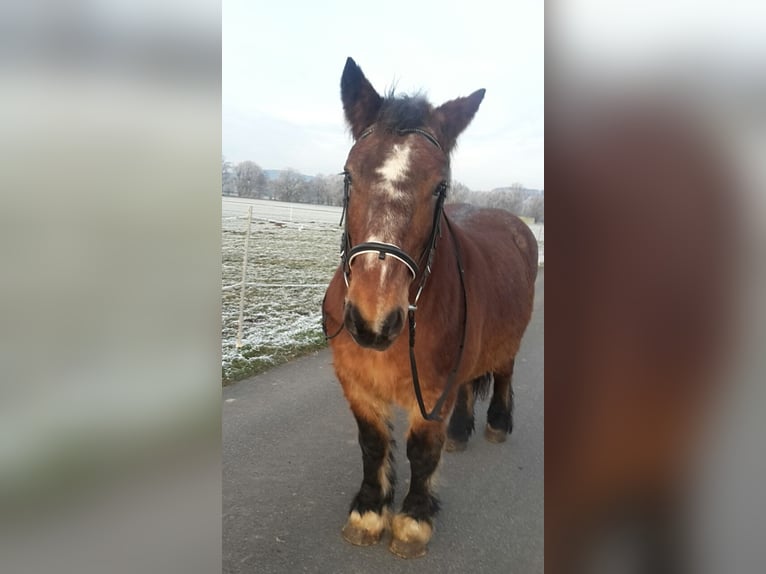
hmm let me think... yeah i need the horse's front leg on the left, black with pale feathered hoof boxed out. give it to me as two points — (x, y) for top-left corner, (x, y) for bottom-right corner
(343, 397), (395, 546)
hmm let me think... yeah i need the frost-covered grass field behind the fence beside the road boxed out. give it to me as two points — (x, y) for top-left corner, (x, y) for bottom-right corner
(221, 205), (341, 384)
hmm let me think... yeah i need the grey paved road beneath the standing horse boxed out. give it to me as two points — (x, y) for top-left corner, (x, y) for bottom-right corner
(223, 272), (544, 574)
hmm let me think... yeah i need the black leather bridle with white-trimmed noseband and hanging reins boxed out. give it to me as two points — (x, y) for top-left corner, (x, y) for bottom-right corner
(322, 126), (468, 422)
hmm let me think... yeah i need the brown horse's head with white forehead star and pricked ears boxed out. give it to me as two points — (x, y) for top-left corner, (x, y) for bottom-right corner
(341, 58), (484, 350)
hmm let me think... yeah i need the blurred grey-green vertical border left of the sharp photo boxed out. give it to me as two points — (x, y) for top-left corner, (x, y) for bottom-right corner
(0, 0), (221, 574)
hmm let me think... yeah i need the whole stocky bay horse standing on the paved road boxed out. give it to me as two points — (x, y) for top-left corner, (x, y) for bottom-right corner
(322, 58), (537, 558)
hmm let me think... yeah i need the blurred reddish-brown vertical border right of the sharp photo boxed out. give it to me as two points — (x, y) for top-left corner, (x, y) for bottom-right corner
(545, 0), (766, 573)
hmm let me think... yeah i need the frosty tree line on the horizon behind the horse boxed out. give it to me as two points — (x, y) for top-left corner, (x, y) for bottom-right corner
(221, 157), (545, 222)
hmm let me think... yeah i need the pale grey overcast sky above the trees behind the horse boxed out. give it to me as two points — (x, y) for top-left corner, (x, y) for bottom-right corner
(223, 0), (544, 194)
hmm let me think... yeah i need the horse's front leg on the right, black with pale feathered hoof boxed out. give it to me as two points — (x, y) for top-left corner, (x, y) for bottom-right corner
(390, 414), (446, 558)
